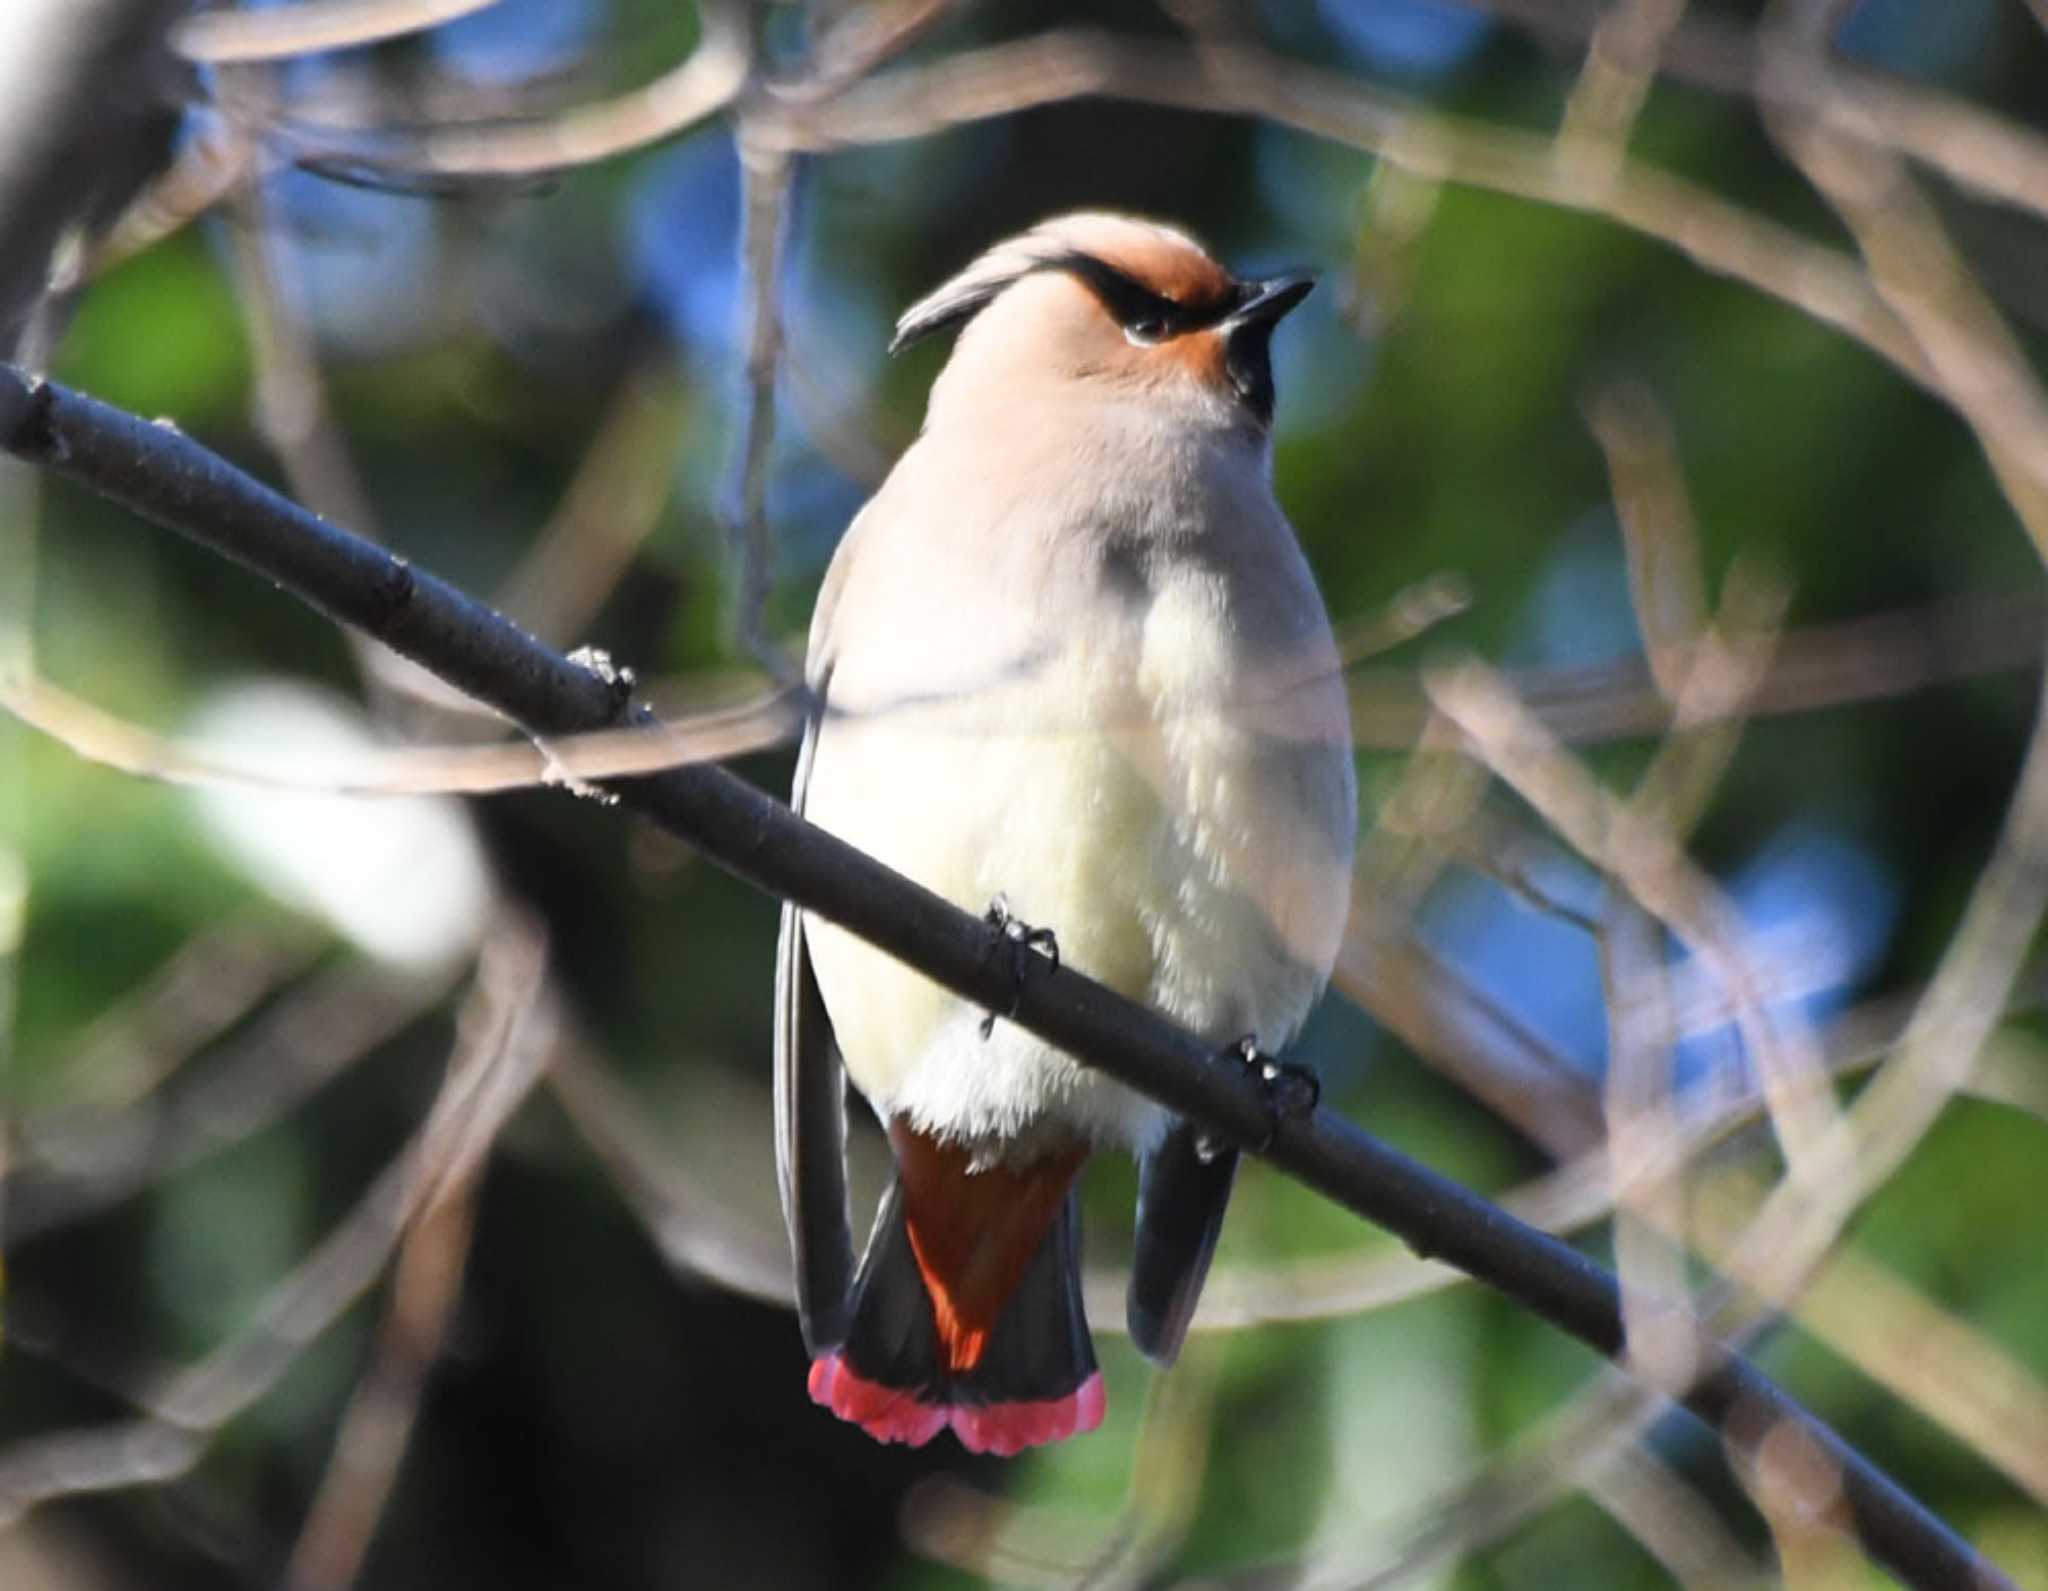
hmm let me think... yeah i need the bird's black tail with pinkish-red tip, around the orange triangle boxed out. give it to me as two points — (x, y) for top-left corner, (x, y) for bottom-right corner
(811, 1181), (1102, 1454)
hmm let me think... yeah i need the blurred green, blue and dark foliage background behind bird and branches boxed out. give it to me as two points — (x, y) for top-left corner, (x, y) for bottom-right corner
(0, 0), (2048, 1591)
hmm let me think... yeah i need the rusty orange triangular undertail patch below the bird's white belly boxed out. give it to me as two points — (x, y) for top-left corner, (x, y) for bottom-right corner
(889, 1122), (1087, 1374)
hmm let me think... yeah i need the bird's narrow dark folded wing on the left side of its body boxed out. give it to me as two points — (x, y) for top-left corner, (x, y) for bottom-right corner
(774, 663), (854, 1358)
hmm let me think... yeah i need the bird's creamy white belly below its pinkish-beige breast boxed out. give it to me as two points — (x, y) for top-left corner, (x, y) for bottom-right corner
(805, 577), (1350, 1153)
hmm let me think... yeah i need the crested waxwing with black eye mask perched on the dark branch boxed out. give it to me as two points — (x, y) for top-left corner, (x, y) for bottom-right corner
(774, 211), (1358, 1456)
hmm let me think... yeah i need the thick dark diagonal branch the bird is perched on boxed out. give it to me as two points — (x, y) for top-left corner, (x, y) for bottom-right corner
(0, 367), (2011, 1591)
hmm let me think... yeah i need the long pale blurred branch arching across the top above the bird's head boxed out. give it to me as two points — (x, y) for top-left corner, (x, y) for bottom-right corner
(211, 20), (1927, 395)
